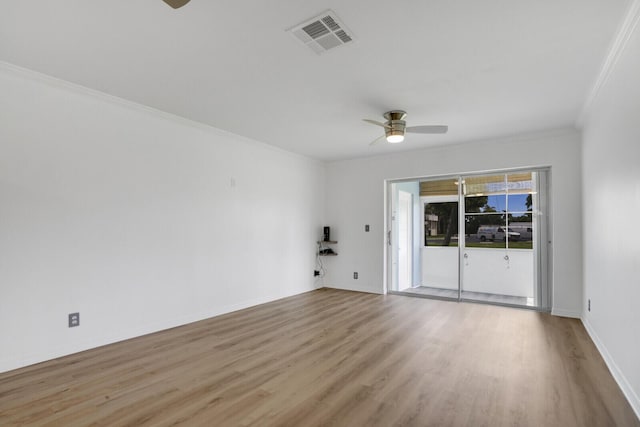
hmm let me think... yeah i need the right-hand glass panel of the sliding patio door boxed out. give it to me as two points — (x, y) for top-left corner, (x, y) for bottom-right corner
(460, 171), (540, 307)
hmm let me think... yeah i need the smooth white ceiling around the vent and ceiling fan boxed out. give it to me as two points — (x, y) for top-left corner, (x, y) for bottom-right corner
(0, 0), (629, 160)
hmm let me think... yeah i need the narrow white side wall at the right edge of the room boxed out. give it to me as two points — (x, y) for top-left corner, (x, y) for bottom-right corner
(583, 1), (640, 416)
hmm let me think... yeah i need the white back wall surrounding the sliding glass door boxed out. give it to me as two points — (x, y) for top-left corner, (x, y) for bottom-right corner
(325, 129), (582, 317)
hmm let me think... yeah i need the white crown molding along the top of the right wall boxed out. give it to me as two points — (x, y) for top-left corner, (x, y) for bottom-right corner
(576, 0), (640, 129)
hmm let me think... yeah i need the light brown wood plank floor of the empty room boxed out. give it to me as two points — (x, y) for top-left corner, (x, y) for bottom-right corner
(0, 290), (640, 427)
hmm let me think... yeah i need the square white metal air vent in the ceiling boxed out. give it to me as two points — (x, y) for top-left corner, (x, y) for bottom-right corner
(287, 10), (354, 54)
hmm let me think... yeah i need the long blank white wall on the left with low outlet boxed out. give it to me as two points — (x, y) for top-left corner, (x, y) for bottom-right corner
(0, 64), (324, 371)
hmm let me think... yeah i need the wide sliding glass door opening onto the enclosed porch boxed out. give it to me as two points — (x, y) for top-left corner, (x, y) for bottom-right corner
(387, 168), (551, 310)
